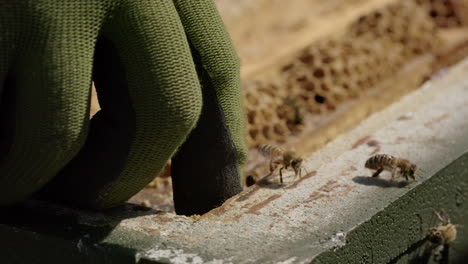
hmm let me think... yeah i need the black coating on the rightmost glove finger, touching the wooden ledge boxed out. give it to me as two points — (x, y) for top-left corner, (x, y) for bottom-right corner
(172, 43), (242, 215)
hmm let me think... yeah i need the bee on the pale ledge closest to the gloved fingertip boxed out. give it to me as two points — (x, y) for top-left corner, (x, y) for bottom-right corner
(258, 144), (304, 184)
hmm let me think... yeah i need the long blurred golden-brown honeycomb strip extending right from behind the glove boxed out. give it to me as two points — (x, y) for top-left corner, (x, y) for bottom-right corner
(243, 1), (441, 147)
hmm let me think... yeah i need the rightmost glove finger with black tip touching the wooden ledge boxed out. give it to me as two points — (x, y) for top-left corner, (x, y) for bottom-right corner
(172, 0), (246, 215)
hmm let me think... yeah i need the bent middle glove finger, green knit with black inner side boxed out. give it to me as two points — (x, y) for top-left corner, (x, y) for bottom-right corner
(44, 0), (201, 208)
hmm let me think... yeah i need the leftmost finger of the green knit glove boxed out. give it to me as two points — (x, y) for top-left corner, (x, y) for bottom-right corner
(0, 1), (104, 204)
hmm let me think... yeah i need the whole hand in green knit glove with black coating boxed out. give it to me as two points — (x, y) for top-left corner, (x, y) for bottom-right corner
(0, 0), (246, 214)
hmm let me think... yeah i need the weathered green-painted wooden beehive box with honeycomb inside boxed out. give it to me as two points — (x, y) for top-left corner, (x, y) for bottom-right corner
(0, 0), (468, 263)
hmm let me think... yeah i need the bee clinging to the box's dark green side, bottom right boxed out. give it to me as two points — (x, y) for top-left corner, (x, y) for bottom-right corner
(428, 208), (459, 245)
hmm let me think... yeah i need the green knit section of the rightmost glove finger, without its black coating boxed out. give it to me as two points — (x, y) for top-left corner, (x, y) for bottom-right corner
(174, 0), (247, 169)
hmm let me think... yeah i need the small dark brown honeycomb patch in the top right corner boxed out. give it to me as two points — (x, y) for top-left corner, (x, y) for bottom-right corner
(415, 0), (468, 28)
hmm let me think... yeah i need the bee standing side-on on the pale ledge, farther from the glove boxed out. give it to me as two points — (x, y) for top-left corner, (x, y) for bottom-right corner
(364, 154), (416, 181)
